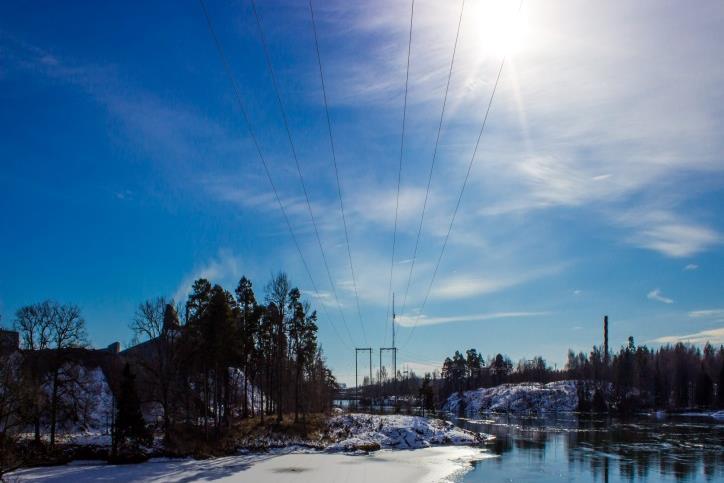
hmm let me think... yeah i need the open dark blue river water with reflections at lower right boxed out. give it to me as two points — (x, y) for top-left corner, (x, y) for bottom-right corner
(456, 414), (724, 482)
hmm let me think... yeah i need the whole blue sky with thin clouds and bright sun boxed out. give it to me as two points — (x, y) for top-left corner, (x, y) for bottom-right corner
(0, 0), (724, 382)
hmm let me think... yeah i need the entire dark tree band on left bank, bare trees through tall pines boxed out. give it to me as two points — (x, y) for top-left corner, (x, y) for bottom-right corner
(0, 273), (338, 467)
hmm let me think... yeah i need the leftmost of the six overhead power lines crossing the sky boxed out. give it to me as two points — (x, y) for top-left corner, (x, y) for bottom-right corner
(199, 0), (354, 347)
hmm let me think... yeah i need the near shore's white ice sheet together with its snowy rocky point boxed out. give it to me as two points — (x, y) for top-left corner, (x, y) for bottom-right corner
(8, 414), (491, 483)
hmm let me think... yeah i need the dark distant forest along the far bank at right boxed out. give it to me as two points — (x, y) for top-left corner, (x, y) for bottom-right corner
(419, 337), (724, 412)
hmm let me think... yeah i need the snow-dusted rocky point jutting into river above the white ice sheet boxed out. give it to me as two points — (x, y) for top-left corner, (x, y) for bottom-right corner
(327, 414), (488, 451)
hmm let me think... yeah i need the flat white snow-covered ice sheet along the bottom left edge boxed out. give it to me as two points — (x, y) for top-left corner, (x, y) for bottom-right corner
(8, 447), (490, 483)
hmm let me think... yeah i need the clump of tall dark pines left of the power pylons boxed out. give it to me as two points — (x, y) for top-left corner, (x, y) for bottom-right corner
(131, 273), (337, 439)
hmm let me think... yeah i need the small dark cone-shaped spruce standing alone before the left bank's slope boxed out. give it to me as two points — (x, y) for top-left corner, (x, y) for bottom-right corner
(113, 363), (151, 457)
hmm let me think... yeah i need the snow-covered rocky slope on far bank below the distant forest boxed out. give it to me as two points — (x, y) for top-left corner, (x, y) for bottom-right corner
(442, 381), (578, 415)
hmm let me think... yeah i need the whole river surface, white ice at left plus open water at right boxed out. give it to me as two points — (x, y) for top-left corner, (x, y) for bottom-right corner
(11, 414), (724, 483)
